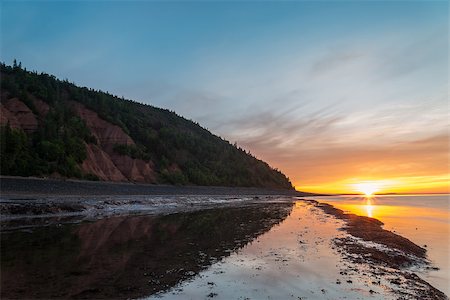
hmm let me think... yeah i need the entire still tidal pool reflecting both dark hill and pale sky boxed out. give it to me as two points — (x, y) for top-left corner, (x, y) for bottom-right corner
(0, 197), (444, 299)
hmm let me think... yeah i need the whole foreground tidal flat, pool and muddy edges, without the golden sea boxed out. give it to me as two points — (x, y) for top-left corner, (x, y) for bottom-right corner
(0, 195), (447, 299)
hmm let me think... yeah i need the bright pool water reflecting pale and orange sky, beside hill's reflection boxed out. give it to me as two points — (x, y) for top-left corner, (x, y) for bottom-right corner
(148, 202), (395, 299)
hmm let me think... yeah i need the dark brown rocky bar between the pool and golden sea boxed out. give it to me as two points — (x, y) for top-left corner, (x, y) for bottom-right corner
(304, 200), (449, 300)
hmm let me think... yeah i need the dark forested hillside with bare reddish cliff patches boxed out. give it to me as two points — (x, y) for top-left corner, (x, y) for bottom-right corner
(0, 63), (292, 189)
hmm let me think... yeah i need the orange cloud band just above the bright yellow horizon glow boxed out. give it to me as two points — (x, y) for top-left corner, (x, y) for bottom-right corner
(251, 133), (449, 186)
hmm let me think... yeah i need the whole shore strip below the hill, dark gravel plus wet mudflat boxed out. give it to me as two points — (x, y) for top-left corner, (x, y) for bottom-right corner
(0, 176), (304, 231)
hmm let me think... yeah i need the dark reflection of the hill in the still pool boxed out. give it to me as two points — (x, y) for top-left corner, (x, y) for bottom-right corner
(1, 203), (292, 298)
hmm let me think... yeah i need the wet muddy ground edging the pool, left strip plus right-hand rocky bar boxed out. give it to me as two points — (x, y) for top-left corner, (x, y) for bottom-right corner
(0, 185), (448, 299)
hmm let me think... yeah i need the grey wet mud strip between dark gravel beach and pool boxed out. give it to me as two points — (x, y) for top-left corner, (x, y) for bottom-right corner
(0, 195), (292, 231)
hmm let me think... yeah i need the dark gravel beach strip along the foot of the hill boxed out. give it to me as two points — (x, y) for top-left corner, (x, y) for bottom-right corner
(0, 176), (310, 197)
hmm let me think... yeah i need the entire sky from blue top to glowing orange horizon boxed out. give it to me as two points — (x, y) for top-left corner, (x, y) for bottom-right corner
(0, 0), (450, 193)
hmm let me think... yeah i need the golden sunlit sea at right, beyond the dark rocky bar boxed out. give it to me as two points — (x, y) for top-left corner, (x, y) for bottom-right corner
(316, 195), (450, 295)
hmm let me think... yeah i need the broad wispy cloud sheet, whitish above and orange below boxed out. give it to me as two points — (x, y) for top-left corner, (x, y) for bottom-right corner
(140, 29), (450, 195)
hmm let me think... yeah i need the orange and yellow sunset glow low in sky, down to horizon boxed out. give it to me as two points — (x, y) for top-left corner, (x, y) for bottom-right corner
(243, 134), (450, 193)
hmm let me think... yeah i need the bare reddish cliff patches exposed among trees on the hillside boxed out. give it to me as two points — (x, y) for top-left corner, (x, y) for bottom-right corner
(0, 93), (156, 183)
